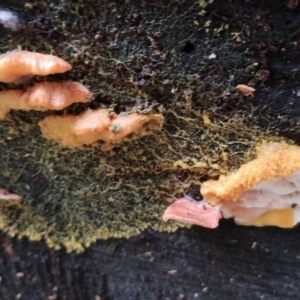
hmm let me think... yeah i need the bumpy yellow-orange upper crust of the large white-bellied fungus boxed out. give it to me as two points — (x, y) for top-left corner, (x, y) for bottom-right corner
(201, 143), (300, 205)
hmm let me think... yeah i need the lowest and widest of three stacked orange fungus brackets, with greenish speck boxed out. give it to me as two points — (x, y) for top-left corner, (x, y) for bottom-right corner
(39, 109), (163, 150)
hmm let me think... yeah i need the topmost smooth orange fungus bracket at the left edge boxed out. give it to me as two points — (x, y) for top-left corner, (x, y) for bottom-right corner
(0, 51), (72, 82)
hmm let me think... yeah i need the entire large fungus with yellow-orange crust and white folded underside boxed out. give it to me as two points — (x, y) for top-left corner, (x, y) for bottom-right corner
(201, 142), (300, 228)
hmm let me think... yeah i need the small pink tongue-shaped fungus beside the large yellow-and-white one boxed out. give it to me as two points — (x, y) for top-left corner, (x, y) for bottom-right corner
(163, 198), (222, 228)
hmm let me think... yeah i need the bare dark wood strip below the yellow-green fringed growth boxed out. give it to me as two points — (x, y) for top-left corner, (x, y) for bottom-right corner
(0, 221), (300, 300)
